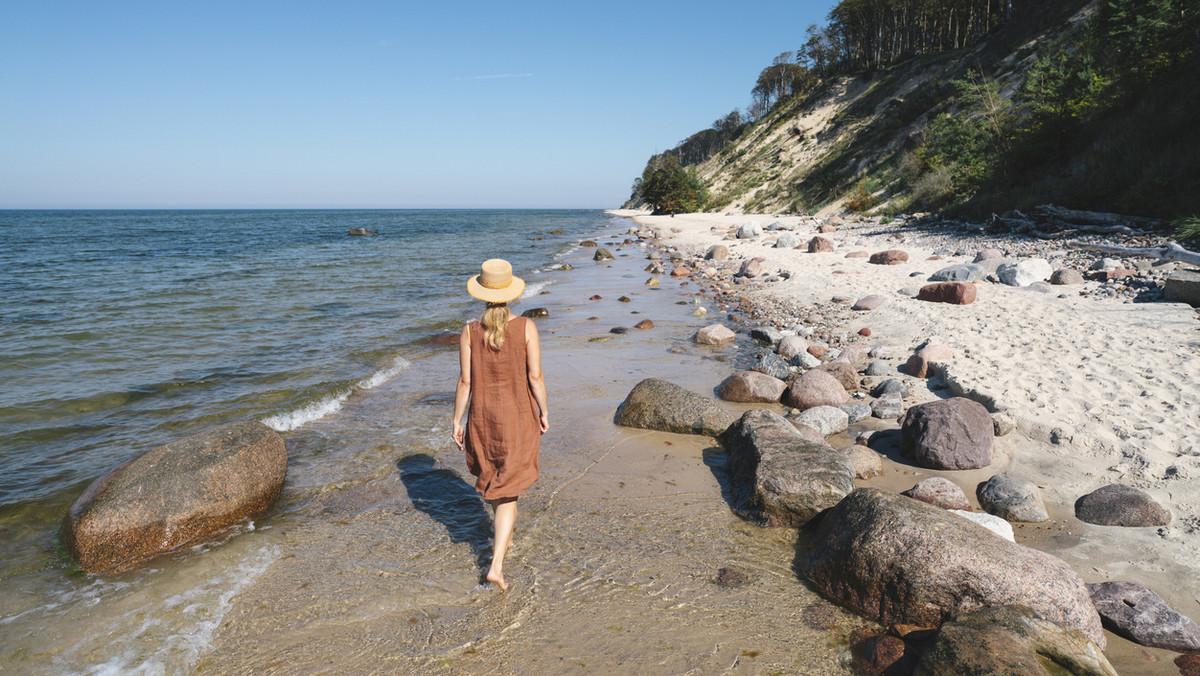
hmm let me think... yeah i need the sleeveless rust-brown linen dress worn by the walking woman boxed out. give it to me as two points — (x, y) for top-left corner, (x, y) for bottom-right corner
(464, 317), (541, 499)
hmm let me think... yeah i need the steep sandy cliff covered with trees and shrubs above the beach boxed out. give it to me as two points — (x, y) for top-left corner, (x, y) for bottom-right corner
(629, 0), (1200, 230)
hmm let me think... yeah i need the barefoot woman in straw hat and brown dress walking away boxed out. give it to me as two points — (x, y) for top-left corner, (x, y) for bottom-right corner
(452, 258), (550, 590)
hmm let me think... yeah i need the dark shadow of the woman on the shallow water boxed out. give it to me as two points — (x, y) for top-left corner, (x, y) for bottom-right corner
(396, 453), (492, 570)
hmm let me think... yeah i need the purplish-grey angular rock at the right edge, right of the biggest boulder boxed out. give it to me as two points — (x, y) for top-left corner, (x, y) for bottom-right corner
(1087, 582), (1200, 653)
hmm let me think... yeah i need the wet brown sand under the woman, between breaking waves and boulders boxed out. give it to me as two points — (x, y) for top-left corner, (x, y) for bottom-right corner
(197, 220), (866, 674)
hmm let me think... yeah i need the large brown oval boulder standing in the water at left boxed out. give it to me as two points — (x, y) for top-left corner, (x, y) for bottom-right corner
(61, 423), (288, 573)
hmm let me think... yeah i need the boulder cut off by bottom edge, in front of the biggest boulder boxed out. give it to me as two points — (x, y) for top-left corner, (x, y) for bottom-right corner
(912, 605), (1117, 676)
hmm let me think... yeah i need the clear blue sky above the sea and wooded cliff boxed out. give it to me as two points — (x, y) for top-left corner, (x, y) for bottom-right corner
(0, 0), (835, 209)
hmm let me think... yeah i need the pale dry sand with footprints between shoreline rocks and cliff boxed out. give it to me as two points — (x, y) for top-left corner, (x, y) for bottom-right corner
(614, 211), (1200, 667)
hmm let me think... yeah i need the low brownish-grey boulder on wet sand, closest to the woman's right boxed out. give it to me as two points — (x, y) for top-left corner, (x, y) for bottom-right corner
(613, 378), (733, 437)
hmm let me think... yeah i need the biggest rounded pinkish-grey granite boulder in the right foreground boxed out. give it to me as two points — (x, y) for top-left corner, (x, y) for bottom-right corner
(804, 489), (1104, 647)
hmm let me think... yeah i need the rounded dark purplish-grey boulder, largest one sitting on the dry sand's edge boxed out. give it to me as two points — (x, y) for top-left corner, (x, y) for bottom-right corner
(900, 396), (995, 469)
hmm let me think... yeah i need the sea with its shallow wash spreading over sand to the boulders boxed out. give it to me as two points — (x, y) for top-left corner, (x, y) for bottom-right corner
(0, 210), (858, 675)
